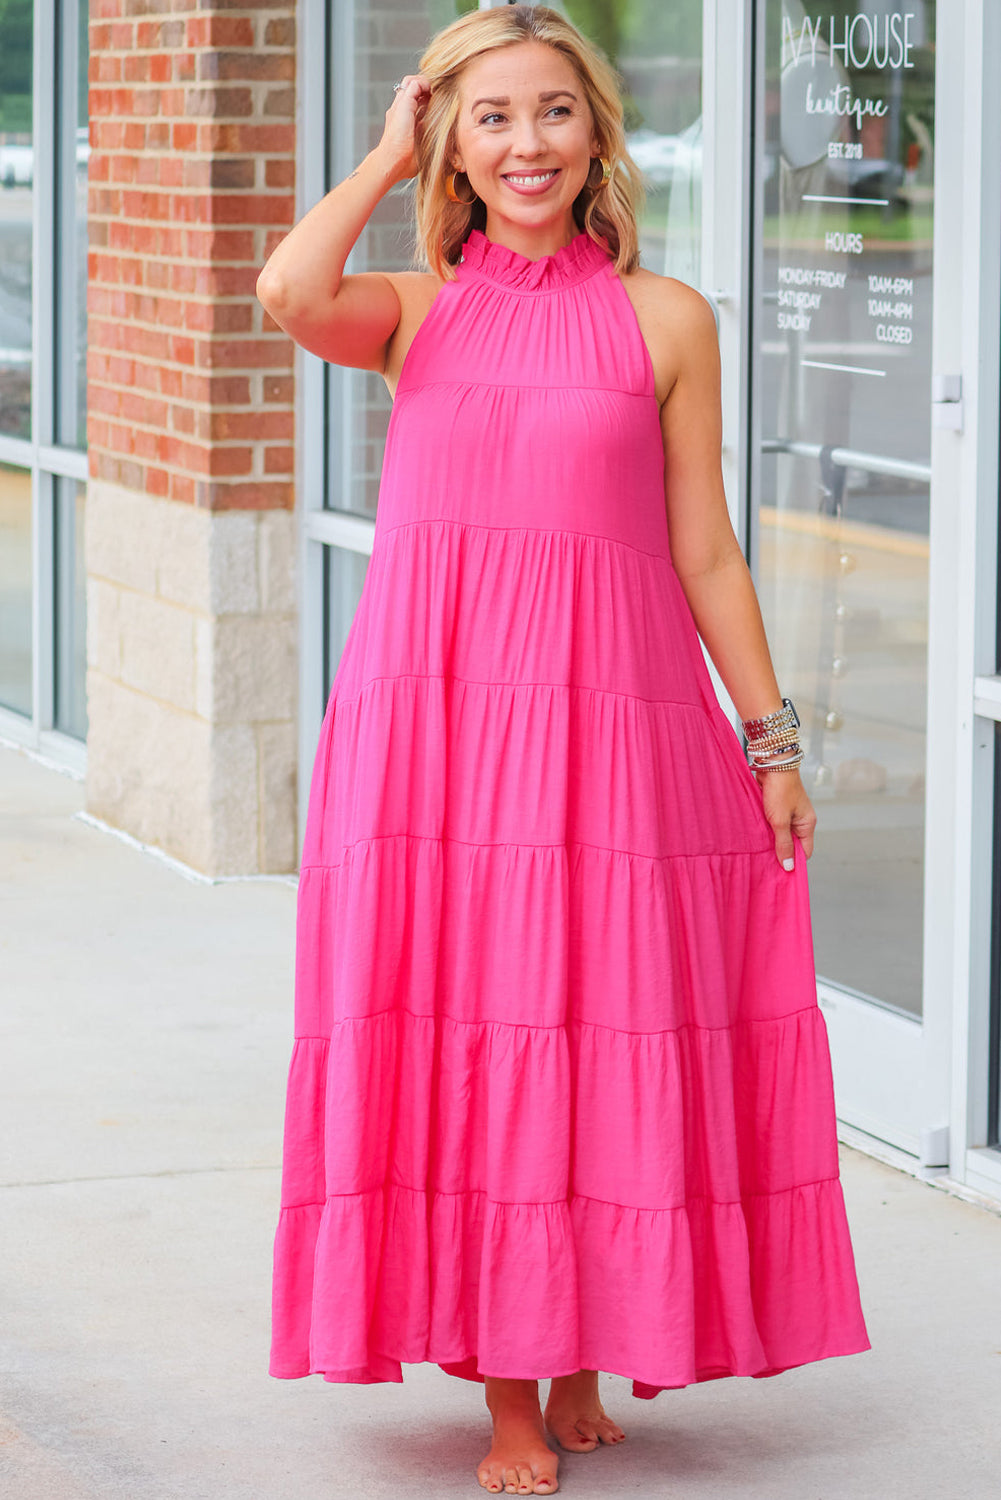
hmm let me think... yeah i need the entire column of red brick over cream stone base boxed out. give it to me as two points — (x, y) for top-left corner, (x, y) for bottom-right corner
(86, 0), (297, 875)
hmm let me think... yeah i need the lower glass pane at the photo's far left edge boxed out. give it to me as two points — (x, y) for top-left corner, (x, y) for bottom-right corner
(0, 464), (32, 717)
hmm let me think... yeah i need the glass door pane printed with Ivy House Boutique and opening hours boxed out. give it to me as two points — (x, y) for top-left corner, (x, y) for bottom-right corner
(756, 0), (935, 1013)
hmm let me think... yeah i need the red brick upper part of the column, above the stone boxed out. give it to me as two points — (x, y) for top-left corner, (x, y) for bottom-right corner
(87, 0), (296, 510)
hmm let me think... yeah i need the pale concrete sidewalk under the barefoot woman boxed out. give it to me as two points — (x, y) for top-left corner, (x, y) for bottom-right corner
(0, 749), (1001, 1500)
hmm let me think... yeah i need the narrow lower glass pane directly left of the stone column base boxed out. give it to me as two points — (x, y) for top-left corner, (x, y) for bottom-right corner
(53, 479), (87, 740)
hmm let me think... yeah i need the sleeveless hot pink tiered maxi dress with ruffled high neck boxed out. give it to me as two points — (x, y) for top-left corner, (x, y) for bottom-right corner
(270, 230), (869, 1397)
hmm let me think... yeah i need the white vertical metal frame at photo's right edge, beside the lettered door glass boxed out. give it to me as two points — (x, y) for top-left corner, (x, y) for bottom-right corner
(942, 0), (1001, 1197)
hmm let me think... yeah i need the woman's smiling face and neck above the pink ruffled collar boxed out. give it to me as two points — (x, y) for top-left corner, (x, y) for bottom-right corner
(453, 41), (600, 254)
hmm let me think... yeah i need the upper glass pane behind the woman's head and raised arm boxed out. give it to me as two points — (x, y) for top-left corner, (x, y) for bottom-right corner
(326, 0), (702, 518)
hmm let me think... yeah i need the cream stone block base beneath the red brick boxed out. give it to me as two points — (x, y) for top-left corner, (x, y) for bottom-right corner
(86, 479), (299, 875)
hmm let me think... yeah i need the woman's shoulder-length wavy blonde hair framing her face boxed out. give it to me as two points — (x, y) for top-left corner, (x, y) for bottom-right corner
(414, 5), (645, 281)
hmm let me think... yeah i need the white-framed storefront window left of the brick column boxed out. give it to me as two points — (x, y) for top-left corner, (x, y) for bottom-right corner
(0, 0), (90, 740)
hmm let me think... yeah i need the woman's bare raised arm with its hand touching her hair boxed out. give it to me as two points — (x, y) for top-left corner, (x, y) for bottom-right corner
(257, 74), (428, 371)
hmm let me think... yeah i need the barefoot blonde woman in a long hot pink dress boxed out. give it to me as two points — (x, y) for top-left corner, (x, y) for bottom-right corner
(258, 6), (869, 1494)
